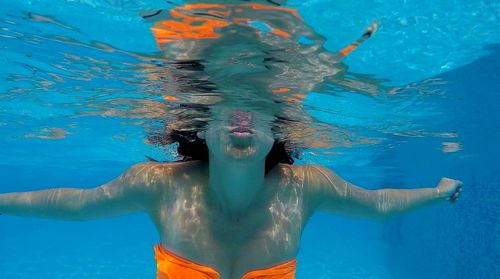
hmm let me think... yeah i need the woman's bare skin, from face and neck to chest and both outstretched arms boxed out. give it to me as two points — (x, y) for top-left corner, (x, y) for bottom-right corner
(0, 109), (461, 279)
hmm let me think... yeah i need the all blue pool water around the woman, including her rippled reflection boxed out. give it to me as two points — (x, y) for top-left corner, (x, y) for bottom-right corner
(0, 0), (500, 278)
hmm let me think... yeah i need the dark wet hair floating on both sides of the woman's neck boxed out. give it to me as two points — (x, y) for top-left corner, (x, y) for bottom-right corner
(148, 130), (298, 174)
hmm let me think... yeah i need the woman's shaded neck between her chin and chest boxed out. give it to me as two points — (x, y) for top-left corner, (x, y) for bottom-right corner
(209, 156), (265, 218)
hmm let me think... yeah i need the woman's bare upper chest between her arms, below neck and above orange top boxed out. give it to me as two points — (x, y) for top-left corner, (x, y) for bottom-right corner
(146, 162), (312, 279)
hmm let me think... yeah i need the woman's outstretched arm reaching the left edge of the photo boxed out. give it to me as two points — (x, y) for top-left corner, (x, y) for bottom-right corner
(0, 163), (171, 220)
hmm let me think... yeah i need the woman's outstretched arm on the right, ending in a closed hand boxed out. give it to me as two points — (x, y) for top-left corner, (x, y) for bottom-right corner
(307, 166), (462, 220)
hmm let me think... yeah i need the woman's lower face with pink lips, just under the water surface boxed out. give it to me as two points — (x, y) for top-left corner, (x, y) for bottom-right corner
(201, 109), (274, 163)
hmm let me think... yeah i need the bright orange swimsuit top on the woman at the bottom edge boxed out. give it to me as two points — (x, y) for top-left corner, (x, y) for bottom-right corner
(154, 245), (297, 279)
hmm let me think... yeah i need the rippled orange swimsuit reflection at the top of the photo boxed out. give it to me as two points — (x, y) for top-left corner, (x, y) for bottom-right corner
(151, 3), (300, 45)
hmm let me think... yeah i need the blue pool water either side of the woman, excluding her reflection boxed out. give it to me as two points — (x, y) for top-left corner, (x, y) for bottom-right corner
(0, 0), (500, 279)
